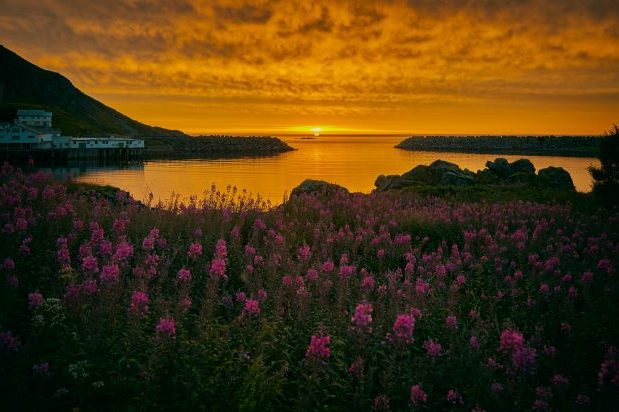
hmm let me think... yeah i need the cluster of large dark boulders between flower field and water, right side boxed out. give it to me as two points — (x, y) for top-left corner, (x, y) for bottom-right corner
(374, 158), (576, 191)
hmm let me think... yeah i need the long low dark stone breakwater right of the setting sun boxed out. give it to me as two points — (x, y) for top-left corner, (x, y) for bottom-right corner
(396, 136), (600, 157)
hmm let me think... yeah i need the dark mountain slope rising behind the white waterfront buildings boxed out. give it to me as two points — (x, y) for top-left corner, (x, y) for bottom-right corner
(0, 45), (186, 138)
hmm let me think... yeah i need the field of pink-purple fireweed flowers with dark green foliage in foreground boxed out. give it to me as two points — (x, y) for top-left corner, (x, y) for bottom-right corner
(0, 164), (619, 411)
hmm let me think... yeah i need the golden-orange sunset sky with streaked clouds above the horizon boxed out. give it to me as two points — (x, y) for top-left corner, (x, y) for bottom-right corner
(0, 0), (619, 135)
